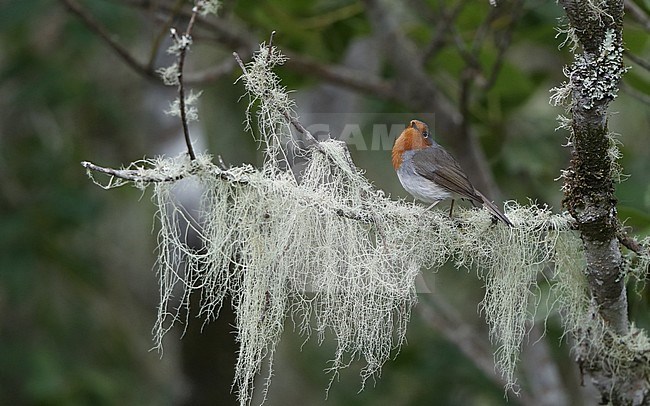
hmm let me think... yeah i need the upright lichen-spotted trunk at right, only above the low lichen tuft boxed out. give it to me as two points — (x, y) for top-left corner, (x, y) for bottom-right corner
(562, 0), (628, 334)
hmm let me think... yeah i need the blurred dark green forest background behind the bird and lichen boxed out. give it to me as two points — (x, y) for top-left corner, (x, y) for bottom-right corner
(0, 0), (650, 405)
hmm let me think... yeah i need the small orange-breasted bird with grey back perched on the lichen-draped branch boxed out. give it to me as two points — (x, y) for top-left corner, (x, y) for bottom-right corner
(393, 120), (512, 227)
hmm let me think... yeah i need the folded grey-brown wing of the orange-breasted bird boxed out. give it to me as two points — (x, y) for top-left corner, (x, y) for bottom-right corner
(413, 145), (483, 203)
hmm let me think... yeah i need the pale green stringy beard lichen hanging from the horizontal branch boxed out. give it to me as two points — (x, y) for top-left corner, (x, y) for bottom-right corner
(81, 42), (648, 405)
